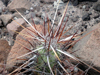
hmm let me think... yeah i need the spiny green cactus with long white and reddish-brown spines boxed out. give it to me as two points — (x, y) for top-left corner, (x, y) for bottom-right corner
(5, 0), (100, 75)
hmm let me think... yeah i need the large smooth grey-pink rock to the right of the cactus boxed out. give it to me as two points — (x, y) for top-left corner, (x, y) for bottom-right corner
(73, 23), (100, 68)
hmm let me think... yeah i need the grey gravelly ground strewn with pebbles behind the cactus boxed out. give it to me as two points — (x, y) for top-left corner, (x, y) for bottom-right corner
(0, 0), (100, 44)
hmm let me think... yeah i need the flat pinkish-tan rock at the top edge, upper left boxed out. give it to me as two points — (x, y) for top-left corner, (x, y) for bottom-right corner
(7, 0), (31, 11)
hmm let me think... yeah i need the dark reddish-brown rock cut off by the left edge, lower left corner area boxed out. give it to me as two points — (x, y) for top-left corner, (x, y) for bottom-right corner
(0, 39), (11, 73)
